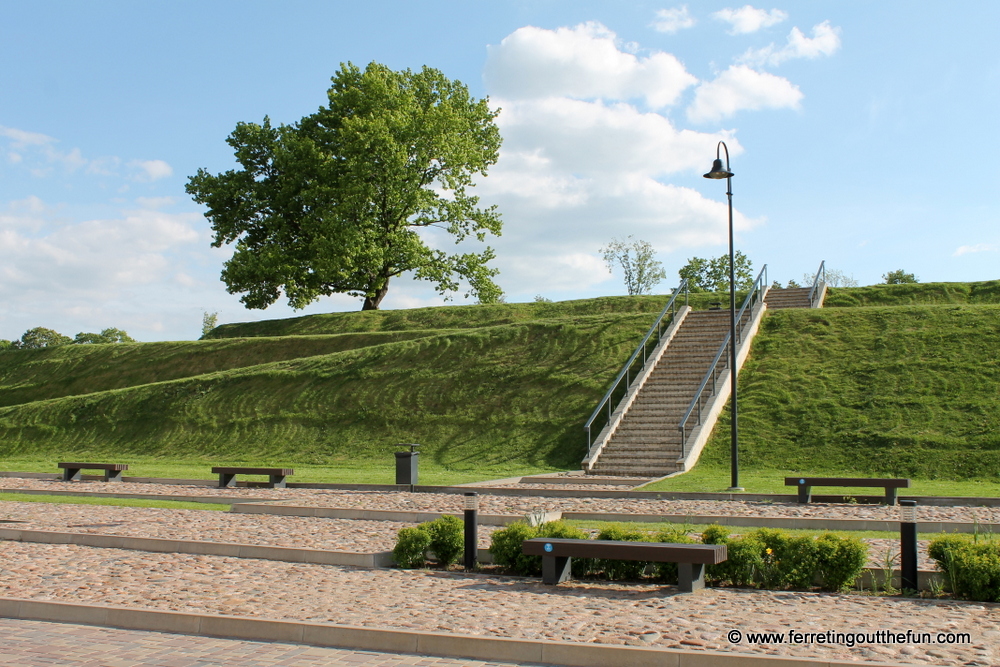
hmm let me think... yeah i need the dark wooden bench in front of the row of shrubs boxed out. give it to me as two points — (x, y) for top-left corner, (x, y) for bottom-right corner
(521, 537), (727, 593)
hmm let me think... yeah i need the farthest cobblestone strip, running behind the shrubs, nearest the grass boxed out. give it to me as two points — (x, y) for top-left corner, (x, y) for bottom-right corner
(0, 477), (1000, 523)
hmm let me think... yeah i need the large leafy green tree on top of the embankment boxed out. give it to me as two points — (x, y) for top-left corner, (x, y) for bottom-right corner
(187, 63), (502, 310)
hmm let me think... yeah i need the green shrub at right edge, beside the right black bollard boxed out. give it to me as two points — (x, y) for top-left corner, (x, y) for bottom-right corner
(927, 535), (1000, 602)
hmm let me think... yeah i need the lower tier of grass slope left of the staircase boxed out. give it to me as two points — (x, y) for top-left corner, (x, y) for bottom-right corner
(0, 314), (662, 468)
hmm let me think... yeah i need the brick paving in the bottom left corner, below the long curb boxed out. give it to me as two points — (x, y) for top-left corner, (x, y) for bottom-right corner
(0, 618), (548, 667)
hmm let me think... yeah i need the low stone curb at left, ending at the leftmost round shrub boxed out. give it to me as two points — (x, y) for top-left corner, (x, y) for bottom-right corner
(0, 528), (393, 568)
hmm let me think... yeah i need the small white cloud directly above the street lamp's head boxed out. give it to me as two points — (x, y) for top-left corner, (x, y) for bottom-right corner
(687, 65), (802, 122)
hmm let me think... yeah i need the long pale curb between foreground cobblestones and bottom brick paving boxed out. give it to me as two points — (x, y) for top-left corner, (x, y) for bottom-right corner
(0, 597), (916, 667)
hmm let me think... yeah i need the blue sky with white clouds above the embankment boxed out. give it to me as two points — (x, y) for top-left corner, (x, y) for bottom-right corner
(0, 0), (1000, 341)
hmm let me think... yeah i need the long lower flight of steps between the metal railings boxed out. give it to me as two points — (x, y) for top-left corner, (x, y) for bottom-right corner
(588, 310), (748, 477)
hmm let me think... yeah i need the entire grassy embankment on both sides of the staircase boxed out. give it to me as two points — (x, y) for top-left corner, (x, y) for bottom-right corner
(0, 281), (1000, 495)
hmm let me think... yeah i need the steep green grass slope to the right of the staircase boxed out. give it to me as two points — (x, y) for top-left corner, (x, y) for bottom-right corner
(699, 306), (1000, 481)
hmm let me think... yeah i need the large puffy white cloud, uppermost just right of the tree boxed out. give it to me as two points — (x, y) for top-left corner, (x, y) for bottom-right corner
(484, 22), (698, 109)
